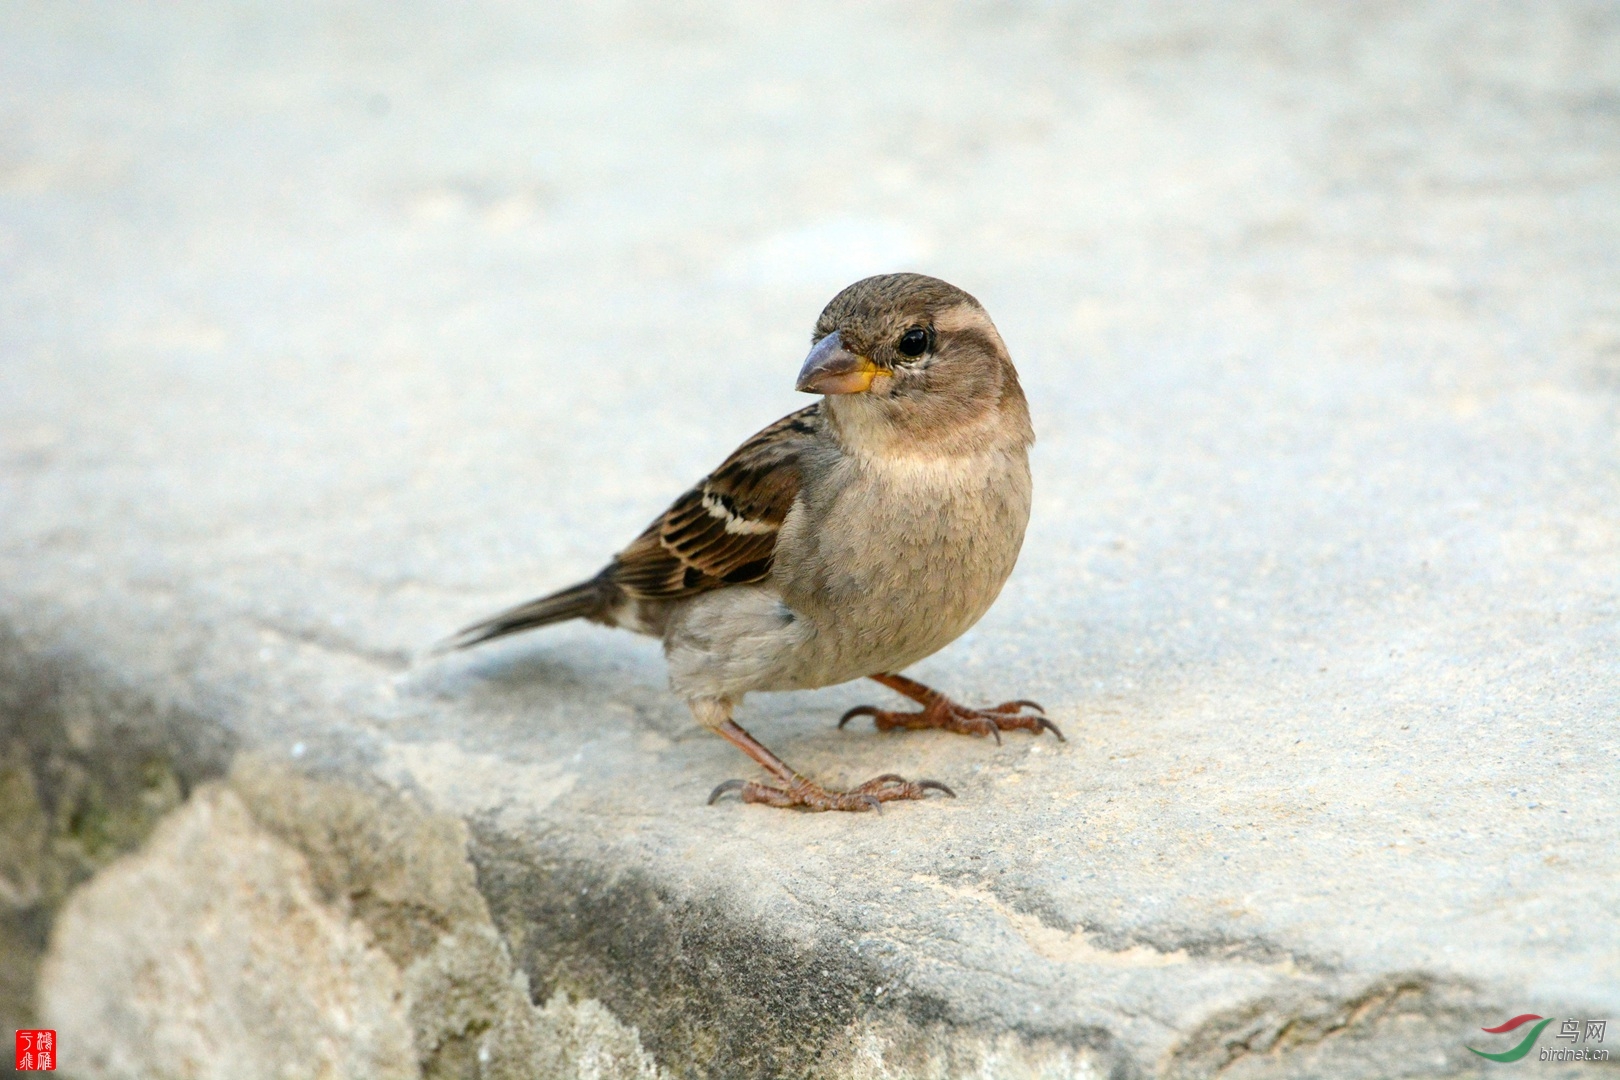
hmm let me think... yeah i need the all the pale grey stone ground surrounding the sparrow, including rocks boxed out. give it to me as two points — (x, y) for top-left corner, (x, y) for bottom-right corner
(0, 2), (1620, 1078)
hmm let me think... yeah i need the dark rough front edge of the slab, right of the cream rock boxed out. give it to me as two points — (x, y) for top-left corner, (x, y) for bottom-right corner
(471, 823), (1137, 1078)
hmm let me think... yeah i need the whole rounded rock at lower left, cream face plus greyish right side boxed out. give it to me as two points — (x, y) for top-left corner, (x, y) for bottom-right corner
(41, 763), (659, 1080)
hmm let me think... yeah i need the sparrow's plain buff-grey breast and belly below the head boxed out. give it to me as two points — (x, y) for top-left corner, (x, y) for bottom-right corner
(776, 453), (1029, 685)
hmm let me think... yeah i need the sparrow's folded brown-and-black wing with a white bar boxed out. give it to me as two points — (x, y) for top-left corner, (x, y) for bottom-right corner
(608, 403), (821, 601)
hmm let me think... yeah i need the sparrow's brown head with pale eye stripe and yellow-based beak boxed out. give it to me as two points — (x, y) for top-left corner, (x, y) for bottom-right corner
(797, 274), (1029, 453)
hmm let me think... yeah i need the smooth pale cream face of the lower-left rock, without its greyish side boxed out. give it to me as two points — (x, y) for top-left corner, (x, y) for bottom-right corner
(42, 789), (416, 1080)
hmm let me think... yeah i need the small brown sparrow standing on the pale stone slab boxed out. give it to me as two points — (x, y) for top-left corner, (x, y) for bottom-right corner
(441, 274), (1063, 811)
